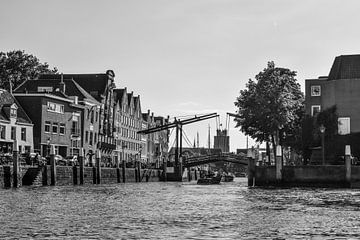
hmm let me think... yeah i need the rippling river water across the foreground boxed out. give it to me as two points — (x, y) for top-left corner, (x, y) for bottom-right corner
(0, 178), (360, 239)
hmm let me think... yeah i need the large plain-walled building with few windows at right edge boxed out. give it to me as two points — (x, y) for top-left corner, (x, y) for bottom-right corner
(305, 55), (360, 161)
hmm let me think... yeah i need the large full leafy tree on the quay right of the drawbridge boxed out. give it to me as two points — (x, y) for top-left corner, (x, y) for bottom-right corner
(235, 62), (304, 157)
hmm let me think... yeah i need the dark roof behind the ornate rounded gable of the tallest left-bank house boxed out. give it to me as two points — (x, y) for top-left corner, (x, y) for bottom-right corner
(39, 73), (113, 100)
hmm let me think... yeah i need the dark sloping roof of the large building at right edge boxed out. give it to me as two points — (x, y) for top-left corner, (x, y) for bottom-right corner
(328, 54), (360, 80)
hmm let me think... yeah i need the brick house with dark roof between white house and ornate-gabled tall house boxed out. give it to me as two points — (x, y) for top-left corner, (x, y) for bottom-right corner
(14, 75), (100, 157)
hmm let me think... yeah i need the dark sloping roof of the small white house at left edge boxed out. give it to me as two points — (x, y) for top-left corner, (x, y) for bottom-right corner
(0, 89), (32, 123)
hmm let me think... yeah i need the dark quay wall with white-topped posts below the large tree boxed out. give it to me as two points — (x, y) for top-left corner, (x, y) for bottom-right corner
(248, 145), (360, 188)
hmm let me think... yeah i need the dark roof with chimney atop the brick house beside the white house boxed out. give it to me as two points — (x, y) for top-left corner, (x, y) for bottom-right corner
(14, 79), (98, 103)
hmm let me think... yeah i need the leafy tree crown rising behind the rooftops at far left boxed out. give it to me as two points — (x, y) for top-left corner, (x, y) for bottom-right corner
(0, 50), (58, 91)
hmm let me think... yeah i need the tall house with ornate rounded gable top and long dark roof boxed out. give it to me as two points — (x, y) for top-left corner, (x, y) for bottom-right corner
(39, 70), (116, 161)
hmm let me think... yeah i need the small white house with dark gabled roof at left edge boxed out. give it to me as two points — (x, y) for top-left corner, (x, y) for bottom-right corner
(0, 89), (34, 154)
